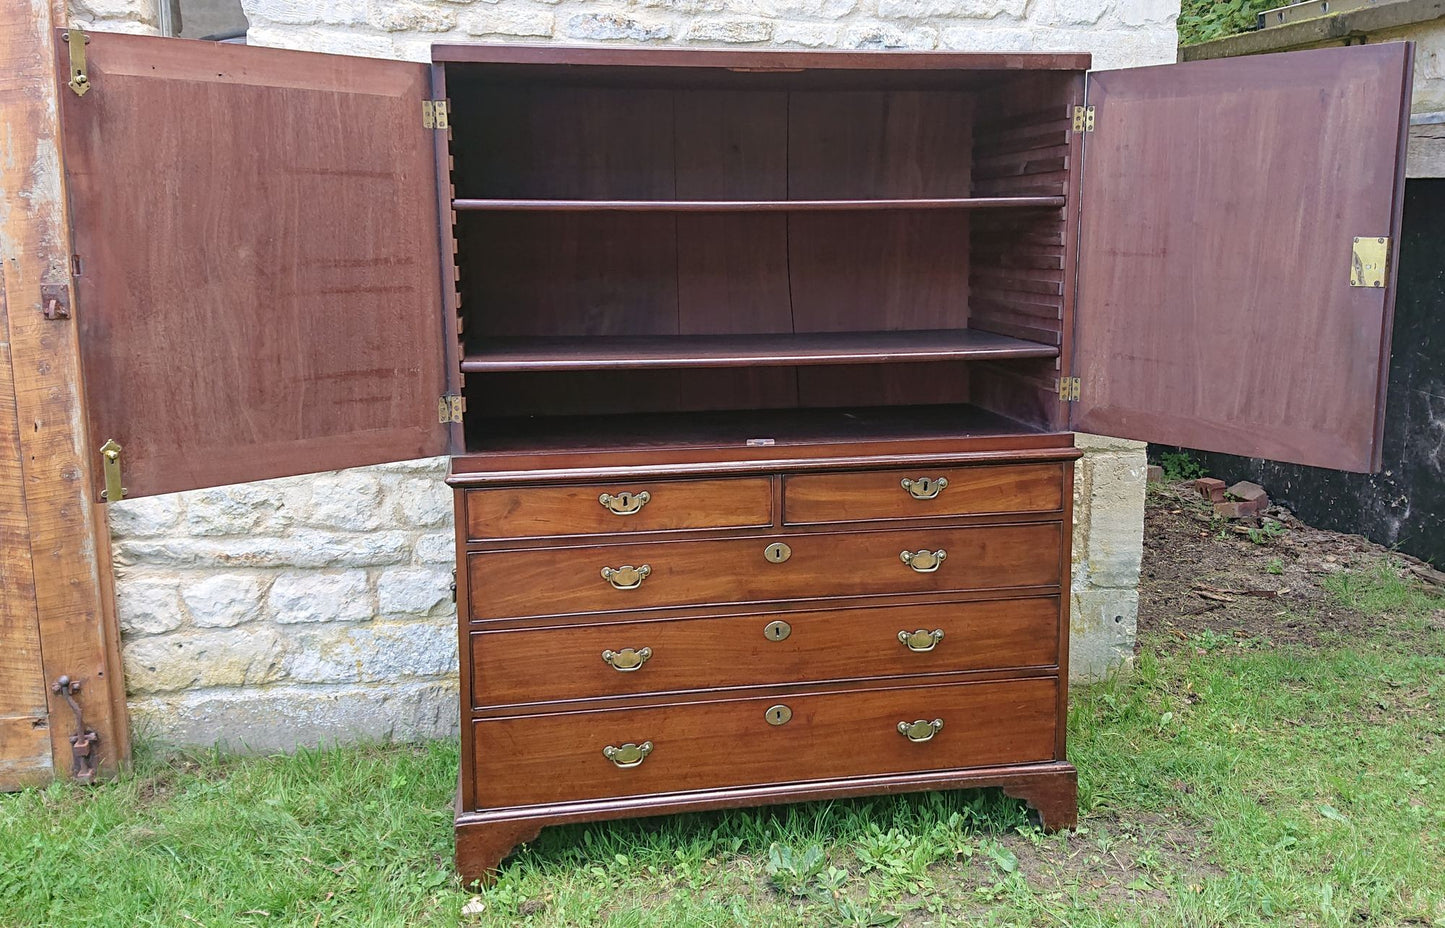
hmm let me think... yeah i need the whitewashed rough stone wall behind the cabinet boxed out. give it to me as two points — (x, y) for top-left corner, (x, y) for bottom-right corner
(96, 0), (1178, 749)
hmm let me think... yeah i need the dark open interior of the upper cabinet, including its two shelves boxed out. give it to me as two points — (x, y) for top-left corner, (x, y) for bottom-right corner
(445, 62), (1082, 451)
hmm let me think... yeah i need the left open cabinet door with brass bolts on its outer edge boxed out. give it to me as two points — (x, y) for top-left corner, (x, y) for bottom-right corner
(61, 33), (449, 497)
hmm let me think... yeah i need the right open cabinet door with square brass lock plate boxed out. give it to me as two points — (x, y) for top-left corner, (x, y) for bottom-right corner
(1071, 43), (1413, 471)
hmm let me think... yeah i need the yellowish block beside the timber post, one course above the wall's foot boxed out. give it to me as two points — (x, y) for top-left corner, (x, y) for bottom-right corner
(121, 629), (285, 692)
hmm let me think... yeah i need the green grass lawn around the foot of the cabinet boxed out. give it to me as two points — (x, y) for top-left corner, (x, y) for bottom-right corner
(0, 567), (1445, 928)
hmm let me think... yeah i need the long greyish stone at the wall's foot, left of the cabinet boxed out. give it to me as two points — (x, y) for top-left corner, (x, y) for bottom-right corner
(130, 679), (460, 752)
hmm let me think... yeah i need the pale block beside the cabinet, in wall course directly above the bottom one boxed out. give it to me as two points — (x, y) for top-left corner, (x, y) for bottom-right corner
(286, 620), (457, 684)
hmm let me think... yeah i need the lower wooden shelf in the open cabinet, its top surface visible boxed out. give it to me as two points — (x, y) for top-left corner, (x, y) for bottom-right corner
(461, 328), (1059, 368)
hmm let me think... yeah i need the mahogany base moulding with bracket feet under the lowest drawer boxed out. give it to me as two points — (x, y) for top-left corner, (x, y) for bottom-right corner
(457, 762), (1078, 883)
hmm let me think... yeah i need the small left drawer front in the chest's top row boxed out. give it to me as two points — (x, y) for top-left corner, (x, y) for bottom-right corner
(465, 477), (773, 541)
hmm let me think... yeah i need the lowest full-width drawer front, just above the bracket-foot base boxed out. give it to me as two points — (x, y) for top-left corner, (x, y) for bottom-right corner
(473, 676), (1058, 808)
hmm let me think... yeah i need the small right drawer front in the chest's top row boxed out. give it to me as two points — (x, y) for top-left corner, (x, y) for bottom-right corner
(783, 464), (1064, 525)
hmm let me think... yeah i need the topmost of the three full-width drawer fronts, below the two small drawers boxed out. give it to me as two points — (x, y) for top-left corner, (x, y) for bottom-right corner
(467, 522), (1062, 620)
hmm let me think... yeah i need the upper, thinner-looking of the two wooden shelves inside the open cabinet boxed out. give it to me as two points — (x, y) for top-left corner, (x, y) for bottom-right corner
(452, 197), (1064, 212)
